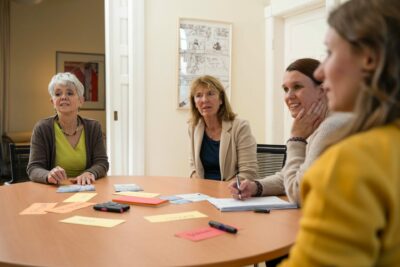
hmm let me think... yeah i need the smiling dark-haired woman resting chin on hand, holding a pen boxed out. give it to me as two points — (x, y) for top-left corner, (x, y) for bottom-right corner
(229, 58), (351, 204)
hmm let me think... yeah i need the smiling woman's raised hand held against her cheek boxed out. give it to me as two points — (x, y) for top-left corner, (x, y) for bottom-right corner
(291, 97), (328, 139)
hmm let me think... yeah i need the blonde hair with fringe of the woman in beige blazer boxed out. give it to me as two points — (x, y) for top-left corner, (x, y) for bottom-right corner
(189, 75), (236, 126)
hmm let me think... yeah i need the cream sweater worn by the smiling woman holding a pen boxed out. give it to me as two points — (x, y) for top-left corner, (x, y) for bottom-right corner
(258, 112), (352, 204)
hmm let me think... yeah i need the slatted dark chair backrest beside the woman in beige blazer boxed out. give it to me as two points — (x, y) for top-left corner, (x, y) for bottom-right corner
(257, 144), (286, 178)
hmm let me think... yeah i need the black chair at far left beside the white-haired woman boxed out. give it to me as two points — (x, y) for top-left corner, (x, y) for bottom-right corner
(4, 143), (31, 185)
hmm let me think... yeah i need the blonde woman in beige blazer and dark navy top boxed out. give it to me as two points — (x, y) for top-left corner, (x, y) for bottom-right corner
(189, 75), (257, 181)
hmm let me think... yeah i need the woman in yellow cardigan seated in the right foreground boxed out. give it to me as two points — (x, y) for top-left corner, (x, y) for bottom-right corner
(282, 0), (400, 266)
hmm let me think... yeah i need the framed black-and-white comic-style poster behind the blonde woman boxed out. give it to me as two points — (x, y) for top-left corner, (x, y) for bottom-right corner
(178, 18), (232, 109)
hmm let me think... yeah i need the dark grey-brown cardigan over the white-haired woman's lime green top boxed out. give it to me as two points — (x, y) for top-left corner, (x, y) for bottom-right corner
(27, 116), (108, 183)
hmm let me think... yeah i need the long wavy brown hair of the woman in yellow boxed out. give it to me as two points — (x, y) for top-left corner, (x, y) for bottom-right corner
(328, 0), (400, 143)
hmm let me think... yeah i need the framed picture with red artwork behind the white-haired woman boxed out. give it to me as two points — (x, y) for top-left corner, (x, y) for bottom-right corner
(56, 51), (106, 110)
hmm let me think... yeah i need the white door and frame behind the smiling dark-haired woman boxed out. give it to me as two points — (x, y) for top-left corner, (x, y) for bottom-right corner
(265, 0), (340, 144)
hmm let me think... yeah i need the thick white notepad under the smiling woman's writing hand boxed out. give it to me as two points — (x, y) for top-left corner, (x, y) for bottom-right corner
(208, 197), (297, 211)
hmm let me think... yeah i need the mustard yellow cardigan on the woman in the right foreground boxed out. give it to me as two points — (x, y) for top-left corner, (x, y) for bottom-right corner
(282, 124), (400, 267)
